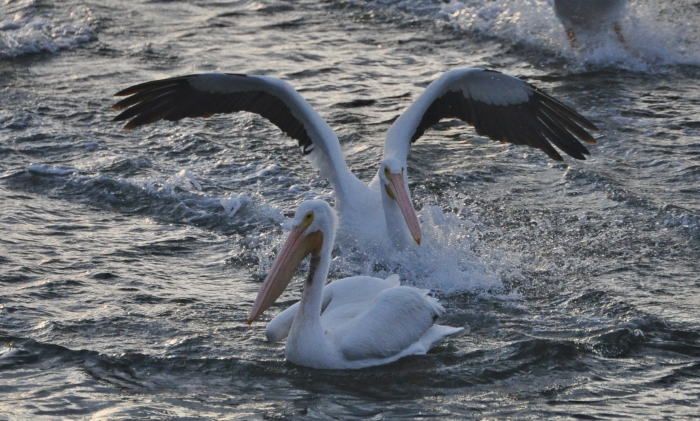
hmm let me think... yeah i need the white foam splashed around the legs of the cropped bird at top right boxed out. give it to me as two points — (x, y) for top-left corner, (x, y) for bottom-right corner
(432, 0), (700, 72)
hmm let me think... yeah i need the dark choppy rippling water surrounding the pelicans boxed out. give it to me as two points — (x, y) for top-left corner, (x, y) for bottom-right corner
(0, 0), (700, 419)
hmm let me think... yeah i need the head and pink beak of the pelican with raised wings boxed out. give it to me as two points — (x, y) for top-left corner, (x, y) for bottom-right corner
(379, 157), (421, 244)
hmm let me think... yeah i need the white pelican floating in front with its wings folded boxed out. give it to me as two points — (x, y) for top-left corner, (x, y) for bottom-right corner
(248, 200), (462, 369)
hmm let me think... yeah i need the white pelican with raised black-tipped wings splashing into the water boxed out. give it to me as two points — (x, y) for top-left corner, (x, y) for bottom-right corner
(112, 69), (597, 249)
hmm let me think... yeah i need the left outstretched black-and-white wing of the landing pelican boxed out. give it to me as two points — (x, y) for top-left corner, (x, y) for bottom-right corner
(112, 73), (358, 188)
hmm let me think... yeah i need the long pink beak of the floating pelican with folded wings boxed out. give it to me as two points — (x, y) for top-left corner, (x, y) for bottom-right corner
(248, 226), (323, 324)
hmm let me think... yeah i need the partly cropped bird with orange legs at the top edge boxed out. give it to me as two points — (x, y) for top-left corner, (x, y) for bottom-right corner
(547, 0), (626, 48)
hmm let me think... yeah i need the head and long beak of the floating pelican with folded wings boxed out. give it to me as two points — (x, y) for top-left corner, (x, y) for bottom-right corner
(248, 200), (338, 324)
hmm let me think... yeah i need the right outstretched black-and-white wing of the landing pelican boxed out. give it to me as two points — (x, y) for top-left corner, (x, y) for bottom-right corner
(384, 68), (598, 163)
